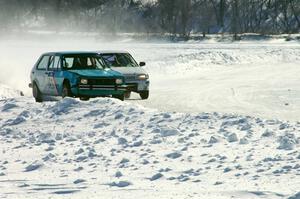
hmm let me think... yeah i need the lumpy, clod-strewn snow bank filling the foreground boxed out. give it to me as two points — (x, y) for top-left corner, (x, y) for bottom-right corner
(0, 98), (300, 199)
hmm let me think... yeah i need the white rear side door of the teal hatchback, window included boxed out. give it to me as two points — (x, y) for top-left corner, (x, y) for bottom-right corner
(35, 55), (50, 94)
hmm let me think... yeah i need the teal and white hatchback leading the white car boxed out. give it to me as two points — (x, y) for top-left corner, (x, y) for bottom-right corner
(29, 52), (126, 102)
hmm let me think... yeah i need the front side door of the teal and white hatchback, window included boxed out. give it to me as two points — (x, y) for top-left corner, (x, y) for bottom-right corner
(47, 55), (61, 96)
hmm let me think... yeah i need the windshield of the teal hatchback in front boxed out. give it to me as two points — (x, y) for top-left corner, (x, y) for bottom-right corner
(62, 55), (106, 70)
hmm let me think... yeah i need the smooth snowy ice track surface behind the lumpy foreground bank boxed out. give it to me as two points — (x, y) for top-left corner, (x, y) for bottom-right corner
(0, 39), (300, 120)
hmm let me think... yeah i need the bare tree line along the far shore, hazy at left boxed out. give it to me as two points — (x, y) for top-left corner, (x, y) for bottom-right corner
(0, 0), (300, 37)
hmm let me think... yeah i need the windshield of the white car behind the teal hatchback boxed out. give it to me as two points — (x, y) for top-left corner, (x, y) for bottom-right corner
(101, 53), (139, 67)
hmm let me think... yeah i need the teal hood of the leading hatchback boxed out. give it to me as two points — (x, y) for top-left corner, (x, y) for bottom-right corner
(69, 69), (122, 77)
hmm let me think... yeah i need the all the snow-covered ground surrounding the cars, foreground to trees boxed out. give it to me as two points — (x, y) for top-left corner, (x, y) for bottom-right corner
(0, 39), (300, 199)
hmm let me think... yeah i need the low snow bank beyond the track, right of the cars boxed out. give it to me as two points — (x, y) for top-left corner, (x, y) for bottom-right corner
(146, 43), (300, 75)
